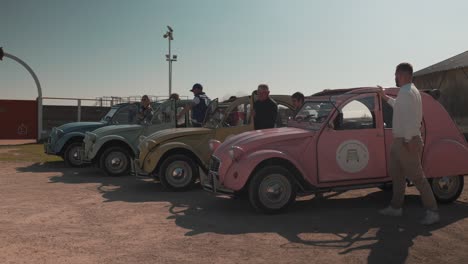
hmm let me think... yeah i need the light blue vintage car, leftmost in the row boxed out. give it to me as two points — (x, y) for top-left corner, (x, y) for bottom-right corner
(44, 103), (155, 167)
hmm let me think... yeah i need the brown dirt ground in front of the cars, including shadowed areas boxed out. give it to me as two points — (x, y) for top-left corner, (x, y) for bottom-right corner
(0, 162), (468, 264)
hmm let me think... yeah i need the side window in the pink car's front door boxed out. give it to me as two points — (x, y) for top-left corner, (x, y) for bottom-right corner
(337, 96), (376, 130)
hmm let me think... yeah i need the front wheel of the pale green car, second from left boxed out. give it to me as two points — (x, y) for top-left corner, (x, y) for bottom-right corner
(99, 147), (131, 177)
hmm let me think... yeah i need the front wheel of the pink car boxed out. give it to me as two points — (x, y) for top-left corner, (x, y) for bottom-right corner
(248, 166), (297, 214)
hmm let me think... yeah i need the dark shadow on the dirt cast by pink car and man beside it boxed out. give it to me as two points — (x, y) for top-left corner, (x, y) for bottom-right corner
(170, 191), (468, 263)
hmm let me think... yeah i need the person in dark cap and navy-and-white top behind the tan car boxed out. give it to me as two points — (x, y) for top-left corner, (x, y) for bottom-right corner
(177, 83), (210, 127)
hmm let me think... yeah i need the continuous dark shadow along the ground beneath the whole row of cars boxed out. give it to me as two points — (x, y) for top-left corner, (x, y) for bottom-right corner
(18, 164), (468, 263)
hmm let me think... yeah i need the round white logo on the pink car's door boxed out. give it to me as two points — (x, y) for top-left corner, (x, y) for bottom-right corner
(336, 140), (369, 173)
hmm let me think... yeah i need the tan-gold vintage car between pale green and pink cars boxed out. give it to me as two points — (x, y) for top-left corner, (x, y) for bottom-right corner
(134, 95), (292, 191)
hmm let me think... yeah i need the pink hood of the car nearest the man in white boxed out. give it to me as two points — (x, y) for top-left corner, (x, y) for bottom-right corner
(214, 127), (315, 156)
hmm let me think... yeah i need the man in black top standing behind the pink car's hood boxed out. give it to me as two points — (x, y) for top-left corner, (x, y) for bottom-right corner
(252, 84), (278, 130)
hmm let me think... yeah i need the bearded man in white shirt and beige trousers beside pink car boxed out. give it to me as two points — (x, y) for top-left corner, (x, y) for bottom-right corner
(379, 63), (440, 225)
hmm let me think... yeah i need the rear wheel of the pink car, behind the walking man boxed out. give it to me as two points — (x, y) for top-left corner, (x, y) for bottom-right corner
(430, 176), (464, 203)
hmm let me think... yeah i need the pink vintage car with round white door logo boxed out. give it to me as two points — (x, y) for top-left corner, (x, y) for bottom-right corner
(201, 88), (468, 213)
